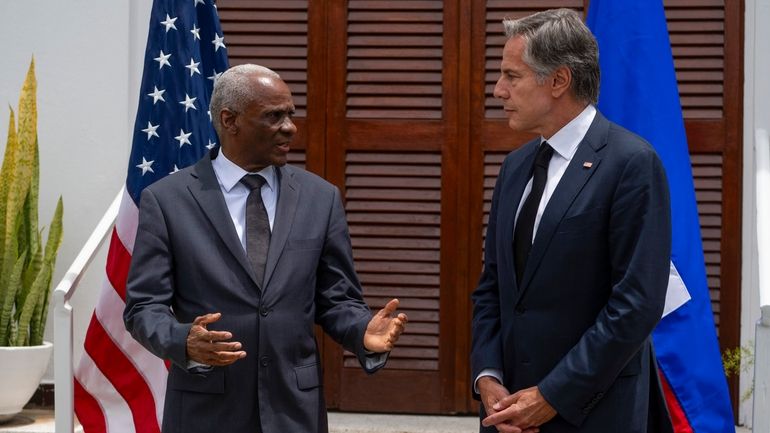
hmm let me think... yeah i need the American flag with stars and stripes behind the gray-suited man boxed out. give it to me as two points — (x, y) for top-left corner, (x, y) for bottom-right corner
(75, 0), (227, 433)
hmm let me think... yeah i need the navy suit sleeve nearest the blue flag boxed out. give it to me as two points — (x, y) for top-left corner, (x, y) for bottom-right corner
(538, 148), (671, 425)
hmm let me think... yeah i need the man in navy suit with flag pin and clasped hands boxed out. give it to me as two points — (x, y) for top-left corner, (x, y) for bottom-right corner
(471, 9), (671, 433)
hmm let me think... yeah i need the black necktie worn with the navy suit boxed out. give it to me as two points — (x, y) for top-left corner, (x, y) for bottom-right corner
(513, 142), (553, 284)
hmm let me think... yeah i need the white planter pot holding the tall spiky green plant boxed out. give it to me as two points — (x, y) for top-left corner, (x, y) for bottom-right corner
(0, 342), (53, 422)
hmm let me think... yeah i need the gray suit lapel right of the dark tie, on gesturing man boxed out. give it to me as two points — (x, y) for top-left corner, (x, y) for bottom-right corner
(264, 166), (299, 287)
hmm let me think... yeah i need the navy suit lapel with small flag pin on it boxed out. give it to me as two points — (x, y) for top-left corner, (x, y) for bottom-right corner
(516, 111), (609, 296)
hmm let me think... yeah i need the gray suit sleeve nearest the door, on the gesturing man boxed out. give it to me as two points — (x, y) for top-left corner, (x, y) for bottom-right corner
(316, 188), (387, 373)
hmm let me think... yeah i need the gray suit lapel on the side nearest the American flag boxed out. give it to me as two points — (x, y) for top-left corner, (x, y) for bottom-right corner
(187, 151), (261, 287)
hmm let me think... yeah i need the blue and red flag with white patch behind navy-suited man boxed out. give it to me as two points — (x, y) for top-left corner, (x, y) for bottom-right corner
(587, 0), (735, 433)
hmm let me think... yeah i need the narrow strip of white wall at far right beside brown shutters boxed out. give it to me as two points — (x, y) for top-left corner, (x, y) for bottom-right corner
(738, 0), (770, 425)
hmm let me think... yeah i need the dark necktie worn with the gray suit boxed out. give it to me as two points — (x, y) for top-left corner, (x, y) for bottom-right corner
(241, 174), (270, 285)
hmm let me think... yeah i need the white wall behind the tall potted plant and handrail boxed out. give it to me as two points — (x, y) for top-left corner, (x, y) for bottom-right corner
(0, 0), (151, 381)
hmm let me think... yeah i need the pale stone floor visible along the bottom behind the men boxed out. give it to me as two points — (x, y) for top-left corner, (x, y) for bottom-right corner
(0, 410), (751, 433)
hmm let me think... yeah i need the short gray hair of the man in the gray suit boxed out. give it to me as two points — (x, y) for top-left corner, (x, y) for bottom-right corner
(209, 63), (281, 134)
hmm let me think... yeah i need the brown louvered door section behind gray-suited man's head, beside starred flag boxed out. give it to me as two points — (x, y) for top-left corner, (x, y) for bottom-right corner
(217, 0), (326, 174)
